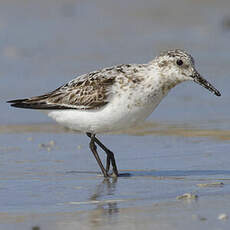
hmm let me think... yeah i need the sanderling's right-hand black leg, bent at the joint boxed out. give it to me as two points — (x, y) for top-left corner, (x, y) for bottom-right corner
(86, 133), (118, 176)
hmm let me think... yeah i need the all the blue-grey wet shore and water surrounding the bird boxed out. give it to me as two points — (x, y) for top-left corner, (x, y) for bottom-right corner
(0, 0), (230, 230)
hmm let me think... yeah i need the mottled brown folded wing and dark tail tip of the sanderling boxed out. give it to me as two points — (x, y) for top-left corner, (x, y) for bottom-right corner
(9, 72), (115, 110)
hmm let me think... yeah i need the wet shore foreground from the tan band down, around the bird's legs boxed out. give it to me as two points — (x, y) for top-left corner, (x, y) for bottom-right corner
(0, 123), (230, 229)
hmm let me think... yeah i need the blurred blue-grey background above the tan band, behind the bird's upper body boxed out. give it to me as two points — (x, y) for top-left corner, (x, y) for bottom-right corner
(0, 0), (230, 128)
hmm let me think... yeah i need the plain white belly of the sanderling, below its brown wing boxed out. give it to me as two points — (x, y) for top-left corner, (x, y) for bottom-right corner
(45, 92), (162, 133)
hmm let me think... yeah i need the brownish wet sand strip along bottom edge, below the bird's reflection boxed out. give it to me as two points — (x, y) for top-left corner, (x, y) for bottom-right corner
(0, 196), (230, 230)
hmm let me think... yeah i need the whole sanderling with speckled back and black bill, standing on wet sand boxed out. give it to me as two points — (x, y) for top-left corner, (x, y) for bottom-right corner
(9, 49), (221, 177)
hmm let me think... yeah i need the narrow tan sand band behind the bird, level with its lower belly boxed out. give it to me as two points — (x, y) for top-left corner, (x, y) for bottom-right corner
(0, 122), (230, 140)
